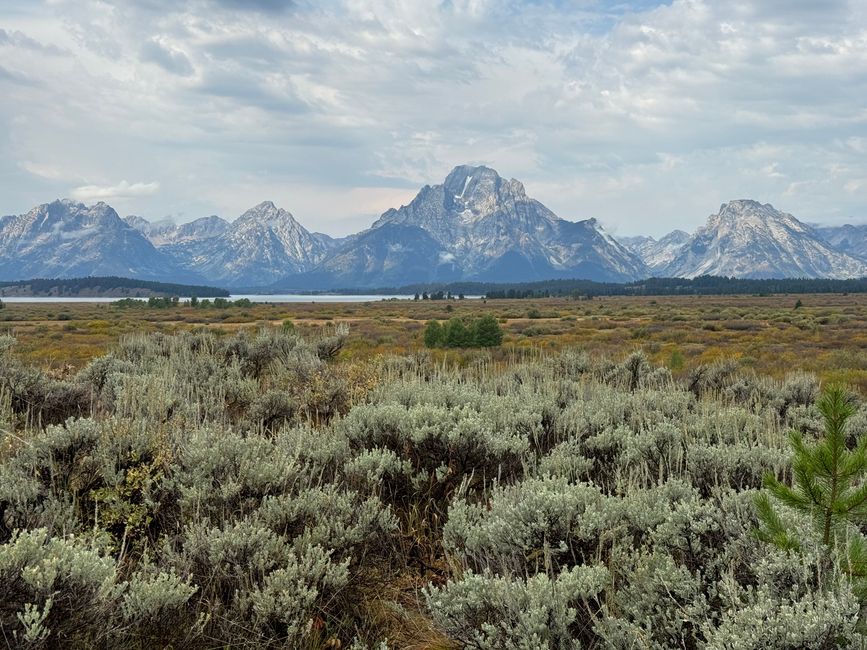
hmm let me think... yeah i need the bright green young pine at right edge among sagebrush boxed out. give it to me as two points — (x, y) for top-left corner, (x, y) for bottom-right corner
(756, 386), (867, 556)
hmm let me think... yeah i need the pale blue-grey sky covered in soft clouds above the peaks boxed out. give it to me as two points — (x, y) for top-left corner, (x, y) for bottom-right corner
(0, 0), (867, 235)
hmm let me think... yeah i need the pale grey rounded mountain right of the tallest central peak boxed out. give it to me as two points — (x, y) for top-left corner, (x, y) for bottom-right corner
(659, 200), (867, 278)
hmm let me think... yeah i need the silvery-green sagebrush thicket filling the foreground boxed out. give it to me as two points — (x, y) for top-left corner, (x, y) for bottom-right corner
(0, 330), (867, 649)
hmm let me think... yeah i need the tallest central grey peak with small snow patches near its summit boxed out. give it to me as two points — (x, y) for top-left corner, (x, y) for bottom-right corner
(364, 165), (646, 280)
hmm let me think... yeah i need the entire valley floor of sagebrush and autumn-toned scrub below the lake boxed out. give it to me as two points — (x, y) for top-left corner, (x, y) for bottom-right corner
(0, 295), (867, 650)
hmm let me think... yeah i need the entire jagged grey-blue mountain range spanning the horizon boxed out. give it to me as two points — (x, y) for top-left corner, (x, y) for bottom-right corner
(0, 165), (867, 291)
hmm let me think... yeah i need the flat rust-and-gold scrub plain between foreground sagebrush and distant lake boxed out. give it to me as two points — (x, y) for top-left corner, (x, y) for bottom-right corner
(0, 294), (867, 394)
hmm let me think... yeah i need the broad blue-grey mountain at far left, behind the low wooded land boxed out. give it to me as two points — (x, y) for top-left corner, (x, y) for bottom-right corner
(0, 200), (201, 281)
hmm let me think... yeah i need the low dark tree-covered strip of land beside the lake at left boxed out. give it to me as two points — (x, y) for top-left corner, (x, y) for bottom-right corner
(0, 276), (229, 298)
